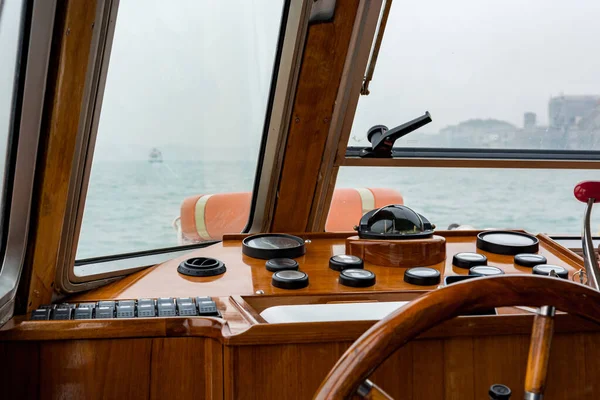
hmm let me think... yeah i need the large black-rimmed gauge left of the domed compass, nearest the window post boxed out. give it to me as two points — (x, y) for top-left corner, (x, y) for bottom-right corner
(242, 233), (306, 260)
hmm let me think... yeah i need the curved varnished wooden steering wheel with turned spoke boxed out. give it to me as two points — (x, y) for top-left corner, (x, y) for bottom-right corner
(314, 275), (600, 400)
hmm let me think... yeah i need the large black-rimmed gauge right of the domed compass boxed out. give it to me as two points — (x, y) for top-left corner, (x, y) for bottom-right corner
(477, 231), (540, 256)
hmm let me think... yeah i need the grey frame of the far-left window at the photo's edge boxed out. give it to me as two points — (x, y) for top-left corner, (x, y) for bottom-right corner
(0, 0), (56, 326)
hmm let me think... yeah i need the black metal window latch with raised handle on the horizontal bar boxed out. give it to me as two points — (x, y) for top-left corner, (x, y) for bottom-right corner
(360, 111), (431, 158)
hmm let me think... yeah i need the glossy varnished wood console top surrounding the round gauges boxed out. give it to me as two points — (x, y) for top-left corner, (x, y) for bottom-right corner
(72, 231), (582, 301)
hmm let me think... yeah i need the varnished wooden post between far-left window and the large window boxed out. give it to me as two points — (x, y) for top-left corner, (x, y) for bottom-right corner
(23, 0), (96, 311)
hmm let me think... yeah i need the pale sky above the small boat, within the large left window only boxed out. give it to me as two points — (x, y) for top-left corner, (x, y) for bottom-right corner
(95, 0), (283, 160)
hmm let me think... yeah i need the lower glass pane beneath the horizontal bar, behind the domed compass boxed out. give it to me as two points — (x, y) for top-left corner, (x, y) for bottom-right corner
(328, 167), (600, 235)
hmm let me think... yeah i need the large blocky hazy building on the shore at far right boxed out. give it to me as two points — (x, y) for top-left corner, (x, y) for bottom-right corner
(548, 96), (600, 130)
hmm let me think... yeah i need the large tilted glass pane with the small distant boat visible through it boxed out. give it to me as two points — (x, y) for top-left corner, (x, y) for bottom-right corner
(77, 0), (284, 259)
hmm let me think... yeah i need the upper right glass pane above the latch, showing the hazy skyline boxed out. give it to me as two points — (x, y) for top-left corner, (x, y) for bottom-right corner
(349, 0), (600, 150)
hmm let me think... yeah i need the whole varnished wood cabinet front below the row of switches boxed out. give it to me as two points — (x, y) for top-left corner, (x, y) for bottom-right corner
(0, 338), (224, 400)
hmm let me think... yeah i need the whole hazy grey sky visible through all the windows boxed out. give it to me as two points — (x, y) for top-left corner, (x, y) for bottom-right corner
(0, 0), (600, 160)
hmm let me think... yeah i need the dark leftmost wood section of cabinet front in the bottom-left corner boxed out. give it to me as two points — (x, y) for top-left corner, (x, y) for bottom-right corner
(0, 342), (40, 400)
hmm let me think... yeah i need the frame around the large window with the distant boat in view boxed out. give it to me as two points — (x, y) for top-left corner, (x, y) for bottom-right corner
(55, 0), (312, 293)
